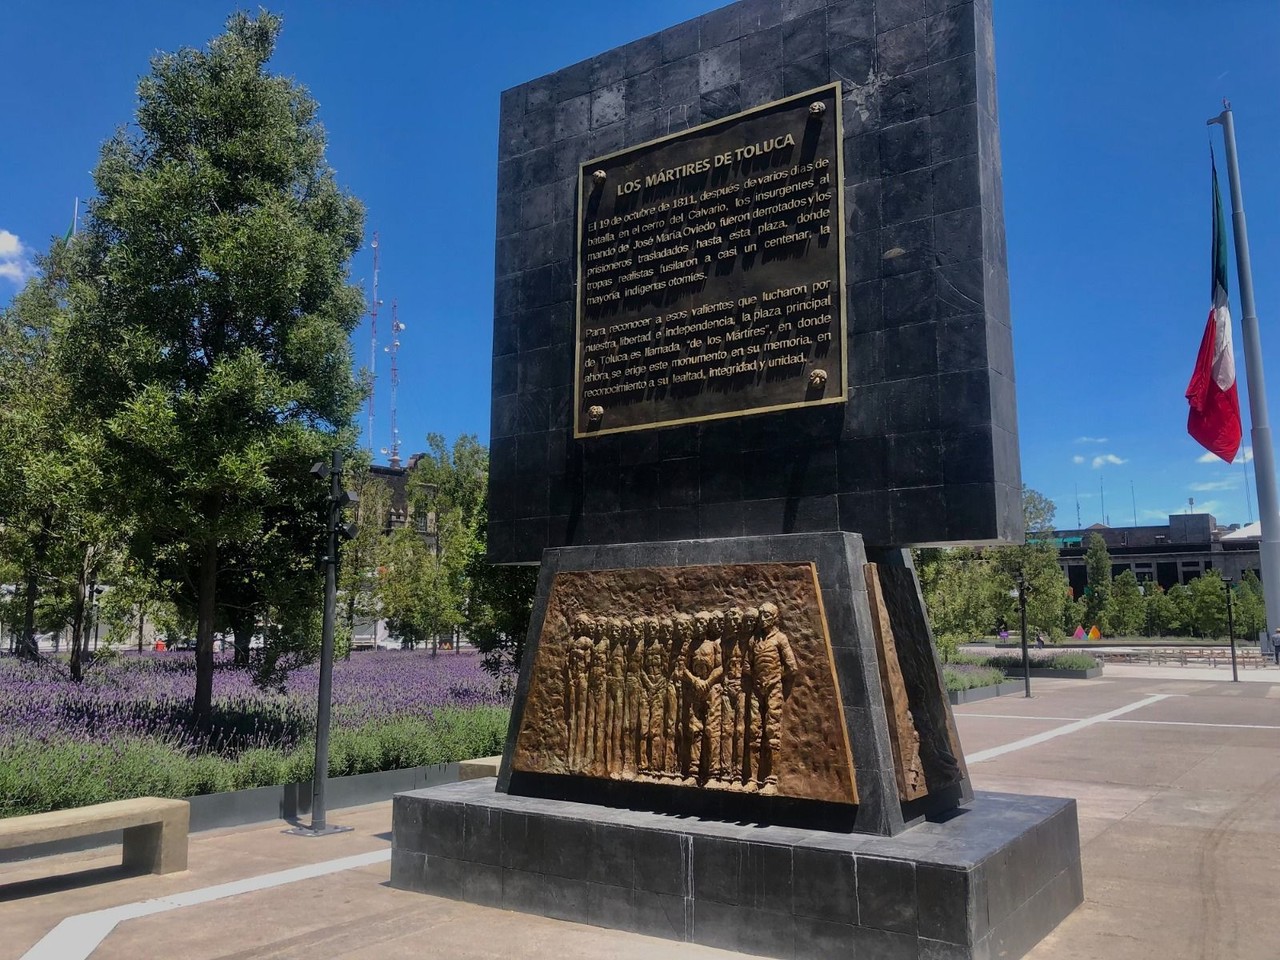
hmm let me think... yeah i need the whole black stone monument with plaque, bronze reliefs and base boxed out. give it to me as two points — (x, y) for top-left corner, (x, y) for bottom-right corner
(392, 0), (1083, 957)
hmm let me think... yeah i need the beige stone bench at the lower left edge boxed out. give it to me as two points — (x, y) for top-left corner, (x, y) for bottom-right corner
(0, 796), (191, 873)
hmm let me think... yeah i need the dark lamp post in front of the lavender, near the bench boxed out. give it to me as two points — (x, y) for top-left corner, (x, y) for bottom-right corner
(285, 451), (360, 837)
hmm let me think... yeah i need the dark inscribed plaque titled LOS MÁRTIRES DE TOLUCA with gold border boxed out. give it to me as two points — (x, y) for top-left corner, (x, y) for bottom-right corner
(573, 83), (846, 436)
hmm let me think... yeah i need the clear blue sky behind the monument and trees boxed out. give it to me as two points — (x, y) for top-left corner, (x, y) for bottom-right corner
(0, 0), (1280, 526)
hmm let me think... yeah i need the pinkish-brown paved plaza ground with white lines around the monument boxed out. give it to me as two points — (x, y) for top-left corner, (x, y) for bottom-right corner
(0, 666), (1280, 960)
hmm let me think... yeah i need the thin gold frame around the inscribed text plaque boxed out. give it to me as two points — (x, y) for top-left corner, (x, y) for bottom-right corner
(573, 81), (849, 440)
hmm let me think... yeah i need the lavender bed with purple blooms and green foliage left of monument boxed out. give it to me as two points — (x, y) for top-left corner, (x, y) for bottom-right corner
(0, 650), (508, 817)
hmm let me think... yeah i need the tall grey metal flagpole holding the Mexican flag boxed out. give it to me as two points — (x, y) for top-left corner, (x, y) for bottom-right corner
(1208, 100), (1280, 647)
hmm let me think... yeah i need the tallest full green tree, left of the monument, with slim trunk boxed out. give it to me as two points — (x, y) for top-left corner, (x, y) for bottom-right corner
(60, 12), (362, 723)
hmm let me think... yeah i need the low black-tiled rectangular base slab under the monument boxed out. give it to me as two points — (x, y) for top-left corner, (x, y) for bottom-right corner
(392, 780), (1083, 960)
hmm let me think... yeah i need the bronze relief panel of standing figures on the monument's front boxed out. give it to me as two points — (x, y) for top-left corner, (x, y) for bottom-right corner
(512, 563), (858, 804)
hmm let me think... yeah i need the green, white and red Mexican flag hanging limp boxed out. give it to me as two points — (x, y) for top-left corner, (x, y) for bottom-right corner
(1187, 155), (1240, 463)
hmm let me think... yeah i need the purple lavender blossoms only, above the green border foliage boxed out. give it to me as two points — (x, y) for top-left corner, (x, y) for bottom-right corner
(0, 650), (508, 756)
